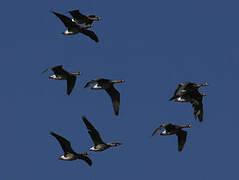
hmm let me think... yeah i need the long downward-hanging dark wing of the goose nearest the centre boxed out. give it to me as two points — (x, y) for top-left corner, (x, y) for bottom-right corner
(105, 85), (120, 116)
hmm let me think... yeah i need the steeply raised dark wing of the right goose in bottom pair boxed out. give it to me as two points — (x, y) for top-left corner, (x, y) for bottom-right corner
(82, 116), (105, 146)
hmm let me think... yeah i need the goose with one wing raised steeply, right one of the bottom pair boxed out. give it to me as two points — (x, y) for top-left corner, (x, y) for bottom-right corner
(82, 116), (122, 151)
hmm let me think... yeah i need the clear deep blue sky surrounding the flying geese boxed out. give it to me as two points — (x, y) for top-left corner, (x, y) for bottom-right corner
(0, 0), (239, 180)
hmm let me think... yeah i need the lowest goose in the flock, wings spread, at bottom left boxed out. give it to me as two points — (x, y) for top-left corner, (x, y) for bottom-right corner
(50, 132), (92, 166)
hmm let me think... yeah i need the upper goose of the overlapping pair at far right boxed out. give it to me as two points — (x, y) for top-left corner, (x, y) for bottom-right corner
(169, 82), (208, 102)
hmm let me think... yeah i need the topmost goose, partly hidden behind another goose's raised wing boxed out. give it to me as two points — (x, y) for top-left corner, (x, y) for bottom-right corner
(68, 9), (101, 25)
